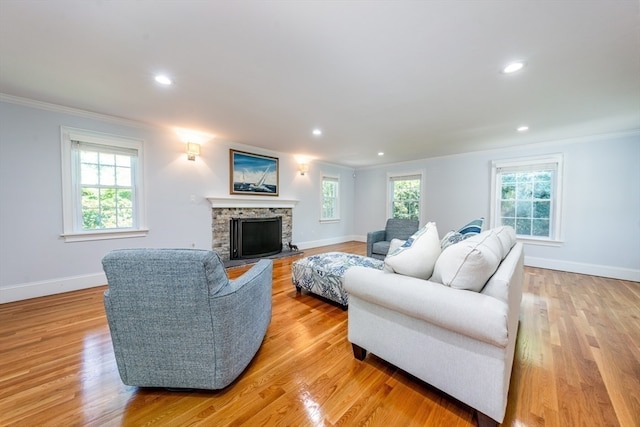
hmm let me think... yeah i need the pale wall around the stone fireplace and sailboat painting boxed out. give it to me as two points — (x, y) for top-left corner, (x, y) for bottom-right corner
(0, 100), (354, 303)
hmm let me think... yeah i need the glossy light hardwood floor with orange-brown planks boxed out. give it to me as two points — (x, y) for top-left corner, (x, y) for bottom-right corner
(0, 242), (640, 427)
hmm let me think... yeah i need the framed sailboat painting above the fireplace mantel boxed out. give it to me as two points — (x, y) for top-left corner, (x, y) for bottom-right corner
(229, 148), (280, 196)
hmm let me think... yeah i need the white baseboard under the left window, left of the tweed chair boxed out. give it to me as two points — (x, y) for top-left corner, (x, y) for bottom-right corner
(0, 273), (107, 304)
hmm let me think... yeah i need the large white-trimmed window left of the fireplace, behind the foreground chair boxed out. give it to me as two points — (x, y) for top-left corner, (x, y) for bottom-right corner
(61, 127), (147, 242)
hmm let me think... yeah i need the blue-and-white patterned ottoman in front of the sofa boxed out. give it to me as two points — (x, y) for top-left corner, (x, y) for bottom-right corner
(291, 252), (384, 308)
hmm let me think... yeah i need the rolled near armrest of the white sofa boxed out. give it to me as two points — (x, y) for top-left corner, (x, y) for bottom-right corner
(343, 267), (508, 347)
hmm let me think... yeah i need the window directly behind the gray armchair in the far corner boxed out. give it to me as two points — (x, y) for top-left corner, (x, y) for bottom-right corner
(387, 173), (422, 220)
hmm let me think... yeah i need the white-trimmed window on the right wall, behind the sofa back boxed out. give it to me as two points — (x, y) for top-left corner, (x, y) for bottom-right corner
(491, 154), (562, 242)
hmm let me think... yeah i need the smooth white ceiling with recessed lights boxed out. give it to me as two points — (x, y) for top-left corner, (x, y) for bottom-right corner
(0, 0), (640, 167)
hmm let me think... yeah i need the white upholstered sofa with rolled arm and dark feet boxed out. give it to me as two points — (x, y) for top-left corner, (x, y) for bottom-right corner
(344, 227), (524, 425)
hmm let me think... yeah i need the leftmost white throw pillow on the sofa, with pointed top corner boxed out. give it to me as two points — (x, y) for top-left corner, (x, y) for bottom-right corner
(384, 222), (441, 280)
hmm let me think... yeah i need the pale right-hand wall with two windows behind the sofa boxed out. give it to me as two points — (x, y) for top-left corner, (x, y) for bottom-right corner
(354, 133), (640, 281)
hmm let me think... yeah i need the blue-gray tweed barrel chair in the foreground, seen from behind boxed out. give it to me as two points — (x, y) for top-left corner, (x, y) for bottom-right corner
(102, 249), (273, 390)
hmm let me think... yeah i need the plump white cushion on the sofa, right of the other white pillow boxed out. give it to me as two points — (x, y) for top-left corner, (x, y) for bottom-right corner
(431, 230), (502, 292)
